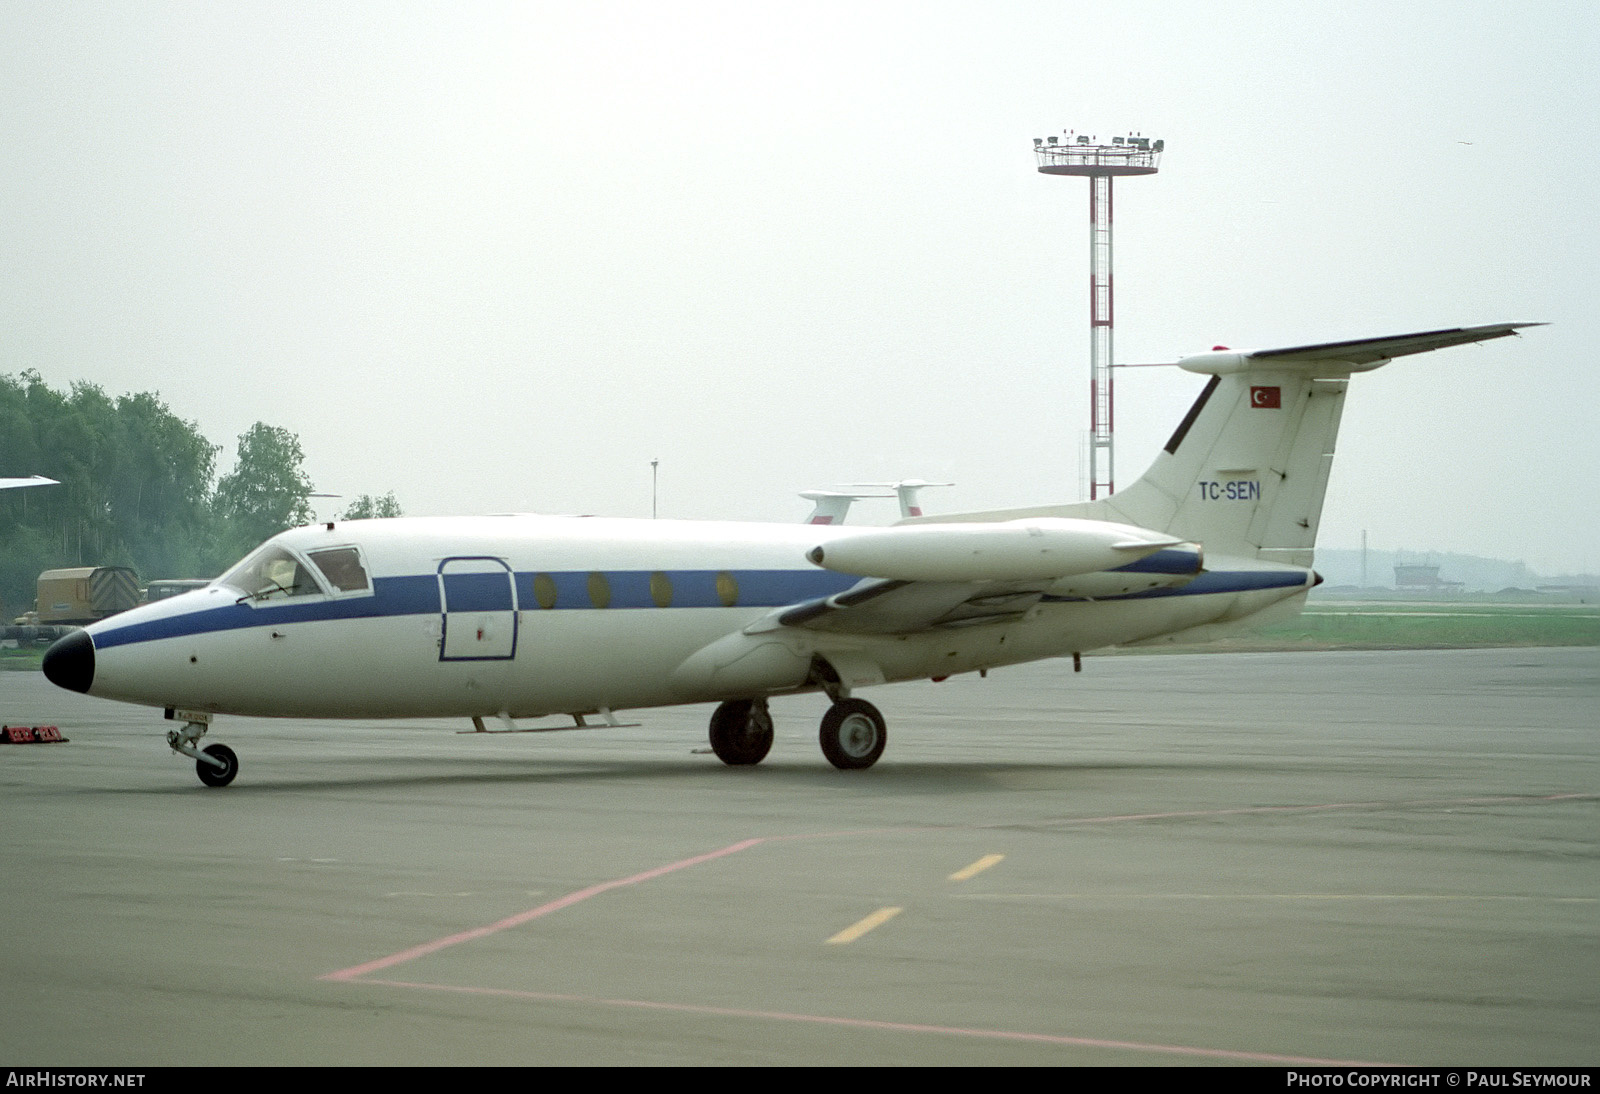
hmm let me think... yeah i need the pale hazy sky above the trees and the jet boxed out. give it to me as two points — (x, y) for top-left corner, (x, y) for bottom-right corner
(0, 0), (1600, 573)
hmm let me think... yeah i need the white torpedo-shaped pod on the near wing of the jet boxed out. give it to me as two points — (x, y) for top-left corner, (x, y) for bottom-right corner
(806, 517), (1182, 581)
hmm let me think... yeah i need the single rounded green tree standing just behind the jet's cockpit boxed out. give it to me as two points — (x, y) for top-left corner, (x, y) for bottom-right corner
(213, 422), (314, 558)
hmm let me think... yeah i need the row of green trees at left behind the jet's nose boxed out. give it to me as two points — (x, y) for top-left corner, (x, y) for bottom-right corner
(0, 371), (400, 619)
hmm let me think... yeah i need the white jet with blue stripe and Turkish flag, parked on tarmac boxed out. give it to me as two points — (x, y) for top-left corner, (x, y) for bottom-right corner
(43, 323), (1530, 785)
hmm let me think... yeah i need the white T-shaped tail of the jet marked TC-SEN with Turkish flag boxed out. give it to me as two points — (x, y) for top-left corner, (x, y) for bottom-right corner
(938, 323), (1538, 566)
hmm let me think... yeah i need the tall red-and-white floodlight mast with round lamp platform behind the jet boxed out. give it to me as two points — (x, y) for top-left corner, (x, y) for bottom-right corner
(1034, 130), (1166, 499)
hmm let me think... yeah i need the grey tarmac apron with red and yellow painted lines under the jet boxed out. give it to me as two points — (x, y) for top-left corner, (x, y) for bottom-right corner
(0, 648), (1600, 1067)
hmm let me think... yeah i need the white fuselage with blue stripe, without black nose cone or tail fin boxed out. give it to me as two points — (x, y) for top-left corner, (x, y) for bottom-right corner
(68, 517), (1312, 718)
